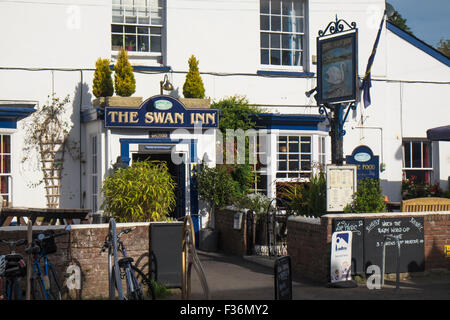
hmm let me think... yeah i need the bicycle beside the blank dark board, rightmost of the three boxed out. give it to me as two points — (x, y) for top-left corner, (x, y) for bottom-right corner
(101, 218), (155, 300)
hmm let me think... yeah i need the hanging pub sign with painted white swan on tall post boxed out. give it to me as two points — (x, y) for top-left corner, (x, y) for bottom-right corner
(317, 28), (358, 104)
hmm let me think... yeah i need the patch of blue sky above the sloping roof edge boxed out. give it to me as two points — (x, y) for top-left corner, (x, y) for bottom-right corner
(386, 0), (450, 46)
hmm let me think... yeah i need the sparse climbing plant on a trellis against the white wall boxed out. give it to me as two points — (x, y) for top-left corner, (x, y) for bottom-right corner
(23, 94), (71, 208)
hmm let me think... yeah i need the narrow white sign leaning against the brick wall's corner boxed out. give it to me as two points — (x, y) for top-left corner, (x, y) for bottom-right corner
(330, 231), (352, 282)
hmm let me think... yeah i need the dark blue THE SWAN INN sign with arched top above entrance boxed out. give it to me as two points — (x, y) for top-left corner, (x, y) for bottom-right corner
(105, 95), (219, 129)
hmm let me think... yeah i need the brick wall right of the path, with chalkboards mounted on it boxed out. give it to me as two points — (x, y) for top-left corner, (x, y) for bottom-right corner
(287, 211), (450, 282)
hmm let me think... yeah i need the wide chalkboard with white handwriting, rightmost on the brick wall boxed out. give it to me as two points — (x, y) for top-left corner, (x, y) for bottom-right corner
(364, 217), (425, 273)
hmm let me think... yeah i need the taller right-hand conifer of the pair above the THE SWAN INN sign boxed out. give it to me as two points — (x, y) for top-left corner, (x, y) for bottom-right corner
(114, 48), (136, 97)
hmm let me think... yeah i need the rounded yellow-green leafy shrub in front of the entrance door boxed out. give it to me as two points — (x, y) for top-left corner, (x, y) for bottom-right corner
(102, 161), (176, 222)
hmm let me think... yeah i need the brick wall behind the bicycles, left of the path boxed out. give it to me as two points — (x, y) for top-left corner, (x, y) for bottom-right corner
(0, 223), (151, 299)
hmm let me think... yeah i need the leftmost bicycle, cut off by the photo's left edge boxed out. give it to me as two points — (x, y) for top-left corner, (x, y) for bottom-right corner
(0, 239), (27, 300)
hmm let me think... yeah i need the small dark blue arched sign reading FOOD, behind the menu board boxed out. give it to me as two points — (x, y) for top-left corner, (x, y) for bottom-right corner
(345, 145), (380, 181)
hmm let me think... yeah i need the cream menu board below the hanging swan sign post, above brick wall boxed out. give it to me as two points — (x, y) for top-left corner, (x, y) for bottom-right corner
(327, 165), (356, 212)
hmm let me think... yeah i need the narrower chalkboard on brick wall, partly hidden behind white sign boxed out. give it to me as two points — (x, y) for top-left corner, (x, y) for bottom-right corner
(333, 219), (364, 275)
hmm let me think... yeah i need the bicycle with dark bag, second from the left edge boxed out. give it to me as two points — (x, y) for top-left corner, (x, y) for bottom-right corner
(25, 225), (70, 300)
